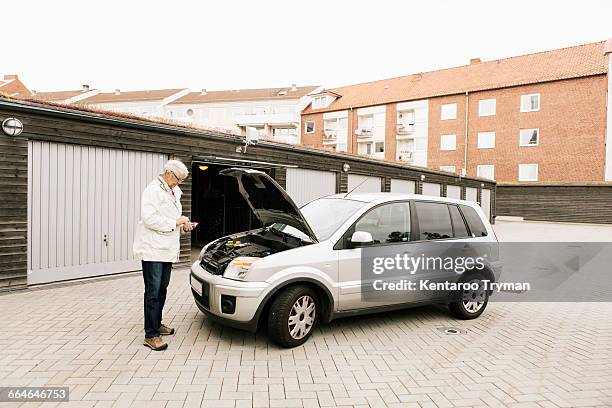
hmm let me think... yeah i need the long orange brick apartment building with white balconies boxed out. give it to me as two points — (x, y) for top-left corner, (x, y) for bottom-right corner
(302, 40), (612, 184)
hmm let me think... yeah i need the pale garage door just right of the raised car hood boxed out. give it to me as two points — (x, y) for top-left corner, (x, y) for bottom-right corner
(287, 168), (336, 207)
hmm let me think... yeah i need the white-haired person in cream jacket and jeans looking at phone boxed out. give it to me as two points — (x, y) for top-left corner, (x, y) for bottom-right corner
(133, 160), (195, 351)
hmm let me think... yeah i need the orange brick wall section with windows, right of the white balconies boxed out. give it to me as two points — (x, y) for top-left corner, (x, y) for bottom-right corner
(428, 75), (607, 183)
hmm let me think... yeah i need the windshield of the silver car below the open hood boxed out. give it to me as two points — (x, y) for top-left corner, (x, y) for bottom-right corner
(300, 198), (366, 241)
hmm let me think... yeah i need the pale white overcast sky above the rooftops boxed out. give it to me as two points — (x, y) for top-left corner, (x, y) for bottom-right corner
(0, 0), (612, 91)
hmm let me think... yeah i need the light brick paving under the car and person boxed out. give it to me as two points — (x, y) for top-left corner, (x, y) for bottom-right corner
(0, 270), (612, 408)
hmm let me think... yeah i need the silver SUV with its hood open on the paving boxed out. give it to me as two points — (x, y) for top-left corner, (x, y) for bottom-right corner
(190, 168), (501, 347)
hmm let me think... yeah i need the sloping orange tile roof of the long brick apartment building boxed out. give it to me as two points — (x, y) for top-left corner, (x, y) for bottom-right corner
(304, 41), (608, 113)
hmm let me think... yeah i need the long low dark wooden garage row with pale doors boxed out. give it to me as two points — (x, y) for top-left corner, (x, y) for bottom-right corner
(0, 98), (495, 290)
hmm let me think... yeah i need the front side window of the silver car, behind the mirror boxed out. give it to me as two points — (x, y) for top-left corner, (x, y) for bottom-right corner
(355, 202), (410, 244)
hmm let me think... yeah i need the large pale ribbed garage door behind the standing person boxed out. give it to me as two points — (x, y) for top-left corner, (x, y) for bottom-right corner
(28, 141), (167, 284)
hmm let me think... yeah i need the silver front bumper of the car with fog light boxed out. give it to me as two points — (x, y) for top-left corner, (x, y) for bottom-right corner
(189, 261), (269, 331)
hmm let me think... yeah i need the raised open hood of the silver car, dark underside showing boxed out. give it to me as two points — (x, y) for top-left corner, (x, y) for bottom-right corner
(219, 167), (318, 242)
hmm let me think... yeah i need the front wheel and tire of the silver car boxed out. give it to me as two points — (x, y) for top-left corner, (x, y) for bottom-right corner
(268, 285), (320, 348)
